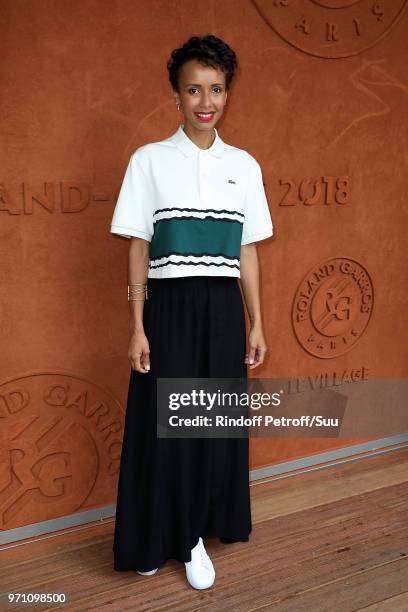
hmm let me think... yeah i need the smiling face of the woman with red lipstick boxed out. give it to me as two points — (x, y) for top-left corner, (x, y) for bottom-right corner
(175, 59), (227, 132)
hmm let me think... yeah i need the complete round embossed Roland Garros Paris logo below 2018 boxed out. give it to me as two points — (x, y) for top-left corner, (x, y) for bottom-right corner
(292, 257), (374, 359)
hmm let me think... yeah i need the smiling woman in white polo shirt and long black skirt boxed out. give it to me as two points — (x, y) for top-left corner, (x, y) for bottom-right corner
(111, 35), (273, 589)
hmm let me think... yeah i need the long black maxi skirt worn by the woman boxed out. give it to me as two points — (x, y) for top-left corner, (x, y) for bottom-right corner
(113, 276), (252, 571)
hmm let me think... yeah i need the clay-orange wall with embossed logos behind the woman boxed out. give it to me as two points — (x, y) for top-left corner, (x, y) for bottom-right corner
(0, 0), (408, 529)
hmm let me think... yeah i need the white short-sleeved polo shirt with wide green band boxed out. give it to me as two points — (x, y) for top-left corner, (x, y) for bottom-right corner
(111, 124), (273, 278)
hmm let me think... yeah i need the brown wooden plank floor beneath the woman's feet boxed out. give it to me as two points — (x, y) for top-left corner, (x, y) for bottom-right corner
(0, 449), (408, 612)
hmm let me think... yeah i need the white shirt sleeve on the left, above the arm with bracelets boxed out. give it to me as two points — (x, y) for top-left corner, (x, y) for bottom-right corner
(110, 151), (153, 242)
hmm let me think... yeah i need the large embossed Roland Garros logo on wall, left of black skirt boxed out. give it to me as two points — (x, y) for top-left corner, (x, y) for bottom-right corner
(0, 371), (124, 529)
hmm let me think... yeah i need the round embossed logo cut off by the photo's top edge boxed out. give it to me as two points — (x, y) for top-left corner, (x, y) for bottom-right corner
(252, 0), (407, 58)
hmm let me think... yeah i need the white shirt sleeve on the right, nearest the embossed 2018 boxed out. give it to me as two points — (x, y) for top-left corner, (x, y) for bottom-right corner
(241, 159), (273, 245)
